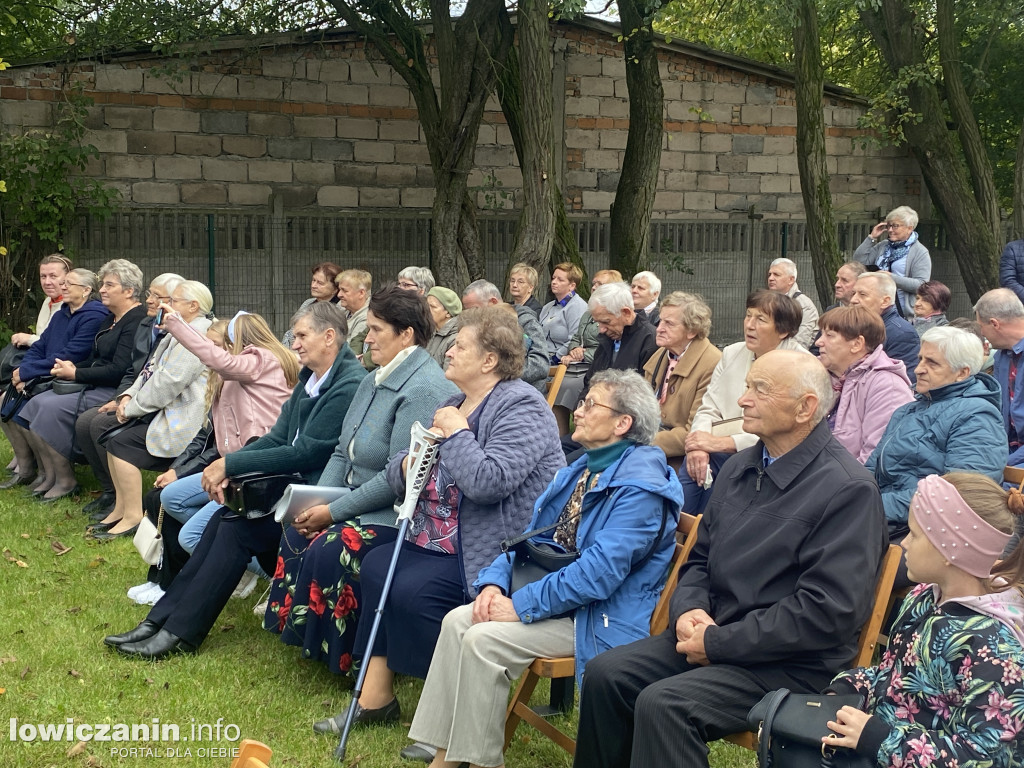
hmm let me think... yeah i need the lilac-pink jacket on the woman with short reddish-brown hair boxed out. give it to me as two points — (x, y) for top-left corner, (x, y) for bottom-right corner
(833, 344), (913, 464)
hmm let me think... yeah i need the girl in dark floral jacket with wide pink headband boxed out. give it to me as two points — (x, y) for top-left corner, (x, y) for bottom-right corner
(822, 472), (1024, 768)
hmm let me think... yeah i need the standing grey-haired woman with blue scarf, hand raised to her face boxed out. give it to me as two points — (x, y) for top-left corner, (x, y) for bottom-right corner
(853, 206), (932, 318)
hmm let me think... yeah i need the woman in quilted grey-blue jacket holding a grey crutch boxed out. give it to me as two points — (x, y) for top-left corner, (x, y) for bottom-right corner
(314, 304), (565, 732)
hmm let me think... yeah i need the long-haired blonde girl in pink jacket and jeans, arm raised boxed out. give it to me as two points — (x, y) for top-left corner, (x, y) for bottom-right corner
(128, 305), (299, 605)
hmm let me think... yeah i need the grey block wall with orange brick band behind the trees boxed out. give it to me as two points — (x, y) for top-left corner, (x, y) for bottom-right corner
(0, 22), (923, 218)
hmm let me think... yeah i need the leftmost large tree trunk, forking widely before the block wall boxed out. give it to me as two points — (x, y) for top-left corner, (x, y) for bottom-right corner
(331, 0), (512, 292)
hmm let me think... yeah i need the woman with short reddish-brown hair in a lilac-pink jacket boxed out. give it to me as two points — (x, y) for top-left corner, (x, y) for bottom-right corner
(815, 306), (913, 464)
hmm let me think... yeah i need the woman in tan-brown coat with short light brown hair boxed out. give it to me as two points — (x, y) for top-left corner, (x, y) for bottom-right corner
(643, 291), (722, 470)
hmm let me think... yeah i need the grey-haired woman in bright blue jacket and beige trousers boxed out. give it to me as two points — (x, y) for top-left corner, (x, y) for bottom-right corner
(399, 370), (683, 766)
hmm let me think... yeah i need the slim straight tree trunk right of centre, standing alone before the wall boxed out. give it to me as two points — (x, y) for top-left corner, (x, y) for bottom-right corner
(793, 0), (843, 305)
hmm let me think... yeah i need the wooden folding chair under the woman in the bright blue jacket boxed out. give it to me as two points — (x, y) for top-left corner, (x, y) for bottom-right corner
(504, 512), (700, 755)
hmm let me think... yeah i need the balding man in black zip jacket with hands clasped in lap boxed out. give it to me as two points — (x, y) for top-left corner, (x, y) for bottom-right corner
(574, 350), (888, 768)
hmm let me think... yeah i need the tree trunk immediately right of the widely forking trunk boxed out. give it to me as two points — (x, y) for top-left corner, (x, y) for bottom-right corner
(497, 10), (589, 297)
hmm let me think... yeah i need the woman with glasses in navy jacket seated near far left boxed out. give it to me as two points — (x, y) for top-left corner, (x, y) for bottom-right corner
(3, 269), (110, 501)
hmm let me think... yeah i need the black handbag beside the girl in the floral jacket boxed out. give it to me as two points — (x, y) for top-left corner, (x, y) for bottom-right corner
(746, 688), (878, 768)
